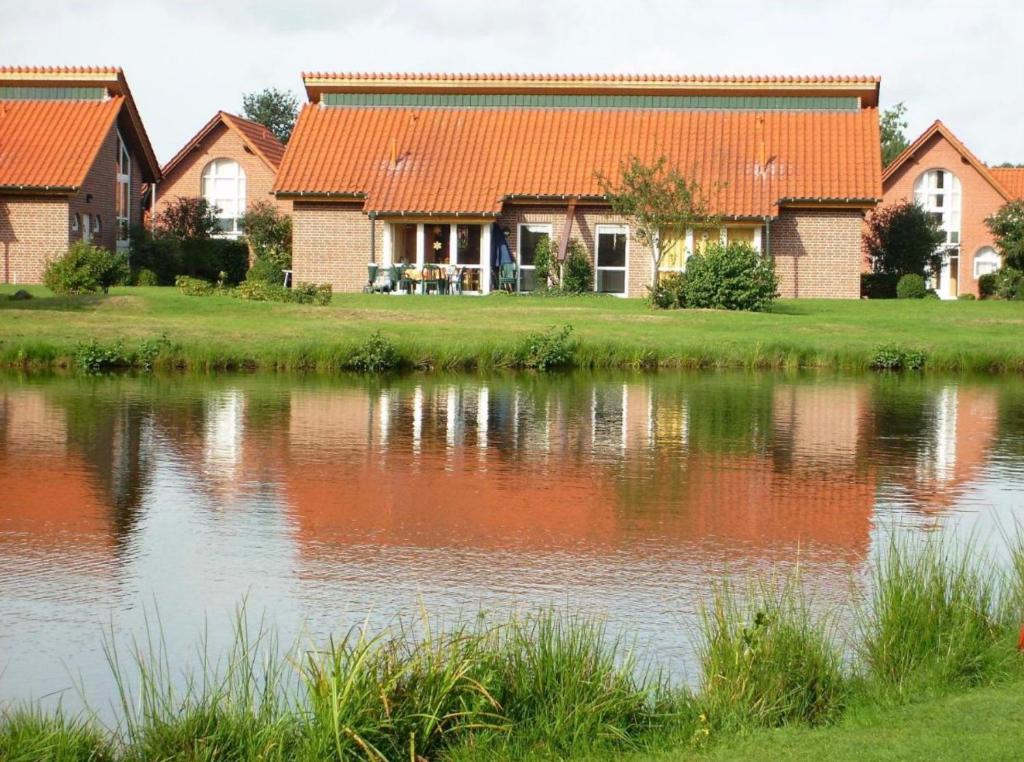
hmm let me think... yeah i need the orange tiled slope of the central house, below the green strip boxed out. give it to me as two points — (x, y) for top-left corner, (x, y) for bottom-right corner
(275, 103), (882, 217)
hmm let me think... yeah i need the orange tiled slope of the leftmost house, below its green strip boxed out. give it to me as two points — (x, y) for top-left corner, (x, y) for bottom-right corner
(0, 96), (124, 189)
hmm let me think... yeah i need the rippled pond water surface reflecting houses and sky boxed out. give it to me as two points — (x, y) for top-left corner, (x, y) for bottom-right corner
(0, 374), (1024, 704)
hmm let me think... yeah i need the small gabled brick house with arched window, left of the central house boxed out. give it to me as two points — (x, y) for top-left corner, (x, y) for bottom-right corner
(154, 112), (292, 238)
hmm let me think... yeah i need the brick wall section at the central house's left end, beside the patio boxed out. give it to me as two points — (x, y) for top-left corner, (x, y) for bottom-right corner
(292, 201), (384, 292)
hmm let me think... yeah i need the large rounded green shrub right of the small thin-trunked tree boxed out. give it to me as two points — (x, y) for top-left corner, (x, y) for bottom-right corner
(684, 243), (778, 312)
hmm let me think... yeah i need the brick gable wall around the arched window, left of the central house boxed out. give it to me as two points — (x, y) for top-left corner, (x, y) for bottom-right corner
(157, 123), (292, 214)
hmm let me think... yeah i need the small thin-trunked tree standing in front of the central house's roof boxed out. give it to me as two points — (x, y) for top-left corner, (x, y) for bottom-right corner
(597, 156), (715, 284)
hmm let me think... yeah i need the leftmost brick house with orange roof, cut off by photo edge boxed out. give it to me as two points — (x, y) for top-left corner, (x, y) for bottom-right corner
(0, 67), (160, 283)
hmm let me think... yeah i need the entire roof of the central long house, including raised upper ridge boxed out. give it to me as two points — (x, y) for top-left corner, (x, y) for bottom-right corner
(274, 74), (882, 217)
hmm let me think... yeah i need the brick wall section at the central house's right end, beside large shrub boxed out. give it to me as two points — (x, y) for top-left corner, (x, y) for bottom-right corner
(770, 209), (863, 299)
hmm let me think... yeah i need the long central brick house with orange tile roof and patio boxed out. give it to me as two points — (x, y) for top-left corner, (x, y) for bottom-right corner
(274, 74), (882, 298)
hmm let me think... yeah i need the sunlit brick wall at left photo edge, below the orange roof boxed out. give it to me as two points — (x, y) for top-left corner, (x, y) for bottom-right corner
(0, 196), (71, 284)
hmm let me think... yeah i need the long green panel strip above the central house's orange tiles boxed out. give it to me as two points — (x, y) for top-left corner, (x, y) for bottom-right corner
(323, 92), (860, 111)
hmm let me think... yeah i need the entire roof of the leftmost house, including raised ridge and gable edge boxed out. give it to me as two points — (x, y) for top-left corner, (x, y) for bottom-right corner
(0, 67), (160, 193)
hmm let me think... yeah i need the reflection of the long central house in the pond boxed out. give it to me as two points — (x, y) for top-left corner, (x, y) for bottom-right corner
(272, 380), (921, 556)
